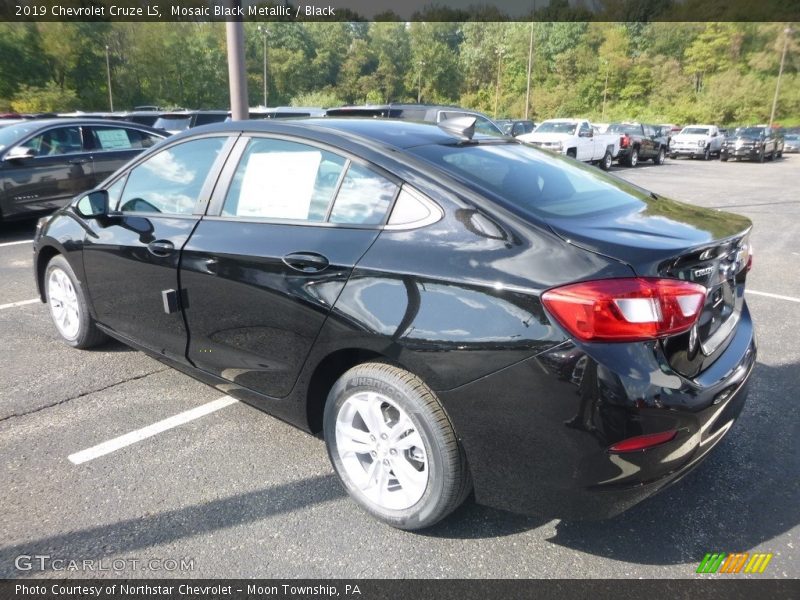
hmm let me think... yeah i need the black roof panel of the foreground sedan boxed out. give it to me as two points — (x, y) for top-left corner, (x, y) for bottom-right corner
(181, 117), (496, 148)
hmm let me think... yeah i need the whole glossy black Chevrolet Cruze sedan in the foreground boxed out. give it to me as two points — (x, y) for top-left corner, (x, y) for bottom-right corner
(34, 117), (756, 529)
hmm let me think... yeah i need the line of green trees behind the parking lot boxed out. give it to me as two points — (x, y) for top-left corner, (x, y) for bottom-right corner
(0, 21), (800, 125)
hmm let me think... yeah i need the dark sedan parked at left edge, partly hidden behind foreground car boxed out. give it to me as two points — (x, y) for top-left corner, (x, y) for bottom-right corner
(0, 118), (166, 220)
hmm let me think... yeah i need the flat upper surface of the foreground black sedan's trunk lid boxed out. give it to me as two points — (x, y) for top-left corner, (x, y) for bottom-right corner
(544, 194), (752, 275)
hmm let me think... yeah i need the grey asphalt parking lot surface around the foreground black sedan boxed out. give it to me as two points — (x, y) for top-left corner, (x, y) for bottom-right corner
(0, 155), (800, 578)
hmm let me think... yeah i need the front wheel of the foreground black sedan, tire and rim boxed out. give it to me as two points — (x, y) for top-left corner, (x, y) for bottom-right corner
(44, 254), (108, 348)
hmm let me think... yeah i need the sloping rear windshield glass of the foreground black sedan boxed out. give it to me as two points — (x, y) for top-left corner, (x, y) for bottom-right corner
(408, 144), (643, 218)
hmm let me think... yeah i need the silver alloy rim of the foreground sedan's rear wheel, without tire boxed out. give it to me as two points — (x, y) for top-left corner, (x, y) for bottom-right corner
(336, 391), (429, 510)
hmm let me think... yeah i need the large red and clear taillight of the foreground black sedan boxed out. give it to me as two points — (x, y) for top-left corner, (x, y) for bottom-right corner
(542, 277), (706, 342)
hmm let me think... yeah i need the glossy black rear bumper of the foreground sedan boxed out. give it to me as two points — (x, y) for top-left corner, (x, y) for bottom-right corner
(439, 306), (756, 519)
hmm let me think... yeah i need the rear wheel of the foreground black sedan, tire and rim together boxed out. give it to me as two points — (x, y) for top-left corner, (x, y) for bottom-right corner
(323, 363), (472, 530)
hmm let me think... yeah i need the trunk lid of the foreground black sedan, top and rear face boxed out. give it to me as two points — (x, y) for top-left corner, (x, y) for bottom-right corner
(545, 195), (752, 376)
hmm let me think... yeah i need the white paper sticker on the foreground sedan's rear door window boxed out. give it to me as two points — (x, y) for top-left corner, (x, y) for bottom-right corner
(236, 151), (322, 219)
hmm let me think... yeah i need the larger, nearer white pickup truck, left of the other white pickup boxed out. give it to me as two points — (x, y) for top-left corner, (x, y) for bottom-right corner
(517, 119), (619, 171)
